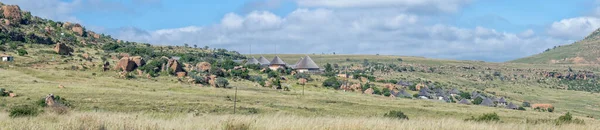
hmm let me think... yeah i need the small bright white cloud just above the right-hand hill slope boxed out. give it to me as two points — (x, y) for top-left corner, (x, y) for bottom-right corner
(548, 17), (600, 40)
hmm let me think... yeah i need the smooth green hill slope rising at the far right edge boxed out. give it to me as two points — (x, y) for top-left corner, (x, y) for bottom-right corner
(510, 29), (600, 64)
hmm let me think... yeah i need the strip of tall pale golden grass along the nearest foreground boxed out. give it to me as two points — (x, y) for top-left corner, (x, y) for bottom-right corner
(0, 112), (600, 130)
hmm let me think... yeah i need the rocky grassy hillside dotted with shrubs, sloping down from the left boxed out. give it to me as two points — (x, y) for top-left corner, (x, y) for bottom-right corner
(0, 2), (600, 129)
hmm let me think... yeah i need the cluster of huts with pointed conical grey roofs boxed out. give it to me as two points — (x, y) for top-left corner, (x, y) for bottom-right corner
(246, 55), (322, 73)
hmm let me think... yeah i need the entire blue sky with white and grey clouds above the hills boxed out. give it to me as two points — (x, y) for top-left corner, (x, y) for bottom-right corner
(0, 0), (600, 62)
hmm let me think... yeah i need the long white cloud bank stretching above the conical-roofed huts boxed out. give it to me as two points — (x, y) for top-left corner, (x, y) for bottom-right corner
(116, 9), (566, 61)
